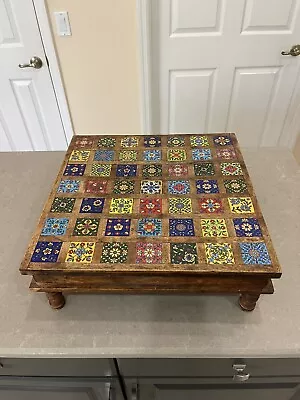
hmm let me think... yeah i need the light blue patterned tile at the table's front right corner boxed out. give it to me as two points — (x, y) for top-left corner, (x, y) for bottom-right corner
(239, 242), (272, 265)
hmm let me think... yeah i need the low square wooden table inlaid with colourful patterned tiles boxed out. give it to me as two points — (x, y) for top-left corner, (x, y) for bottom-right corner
(20, 133), (281, 311)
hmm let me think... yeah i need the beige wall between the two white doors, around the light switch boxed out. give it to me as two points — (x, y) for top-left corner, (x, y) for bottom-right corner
(46, 0), (140, 134)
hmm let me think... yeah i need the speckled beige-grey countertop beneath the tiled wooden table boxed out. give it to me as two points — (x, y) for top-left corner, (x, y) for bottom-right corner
(0, 149), (300, 357)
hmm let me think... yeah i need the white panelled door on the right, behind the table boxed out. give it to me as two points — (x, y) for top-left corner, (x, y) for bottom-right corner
(151, 0), (300, 146)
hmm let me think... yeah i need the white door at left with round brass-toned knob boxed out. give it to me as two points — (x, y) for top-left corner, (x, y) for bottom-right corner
(0, 0), (67, 151)
